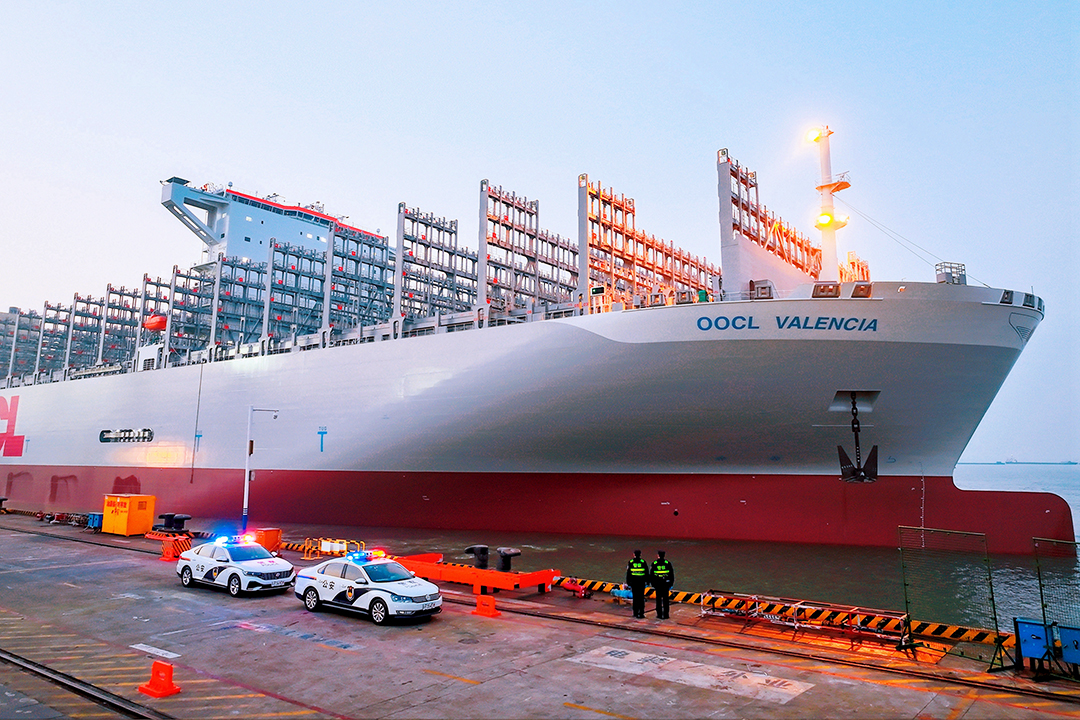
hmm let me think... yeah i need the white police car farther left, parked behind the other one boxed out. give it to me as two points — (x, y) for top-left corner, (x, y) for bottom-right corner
(176, 535), (296, 597)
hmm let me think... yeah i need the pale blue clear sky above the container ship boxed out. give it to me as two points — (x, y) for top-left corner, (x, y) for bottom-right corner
(0, 1), (1080, 461)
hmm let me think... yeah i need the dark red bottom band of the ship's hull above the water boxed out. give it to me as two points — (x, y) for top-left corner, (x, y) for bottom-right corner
(0, 466), (1074, 554)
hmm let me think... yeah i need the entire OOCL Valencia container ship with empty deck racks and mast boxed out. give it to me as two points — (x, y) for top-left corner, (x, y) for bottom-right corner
(0, 127), (1074, 553)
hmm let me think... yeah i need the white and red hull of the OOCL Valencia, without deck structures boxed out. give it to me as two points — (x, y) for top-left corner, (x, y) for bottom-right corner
(0, 283), (1072, 553)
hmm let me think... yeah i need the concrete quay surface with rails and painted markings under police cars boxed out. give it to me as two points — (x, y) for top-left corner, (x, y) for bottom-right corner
(0, 515), (1080, 720)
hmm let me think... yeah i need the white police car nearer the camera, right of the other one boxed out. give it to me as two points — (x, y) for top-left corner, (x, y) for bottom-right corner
(295, 551), (443, 625)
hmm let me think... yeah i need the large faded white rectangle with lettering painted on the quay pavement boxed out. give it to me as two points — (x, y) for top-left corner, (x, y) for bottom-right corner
(566, 646), (813, 705)
